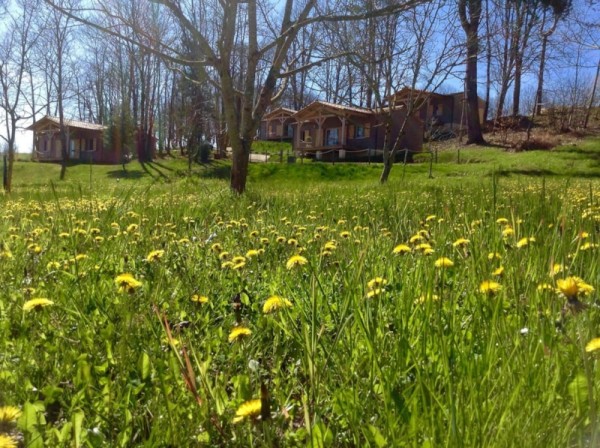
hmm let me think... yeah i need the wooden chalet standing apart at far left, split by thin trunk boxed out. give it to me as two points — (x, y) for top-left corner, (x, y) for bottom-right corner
(27, 115), (116, 163)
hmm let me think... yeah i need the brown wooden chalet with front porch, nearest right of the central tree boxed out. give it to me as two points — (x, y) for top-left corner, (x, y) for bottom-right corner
(293, 101), (423, 160)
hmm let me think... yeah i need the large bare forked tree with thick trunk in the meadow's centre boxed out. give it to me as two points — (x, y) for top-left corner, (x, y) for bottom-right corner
(46, 0), (422, 193)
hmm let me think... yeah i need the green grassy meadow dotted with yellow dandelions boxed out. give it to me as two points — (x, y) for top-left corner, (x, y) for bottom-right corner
(0, 140), (600, 448)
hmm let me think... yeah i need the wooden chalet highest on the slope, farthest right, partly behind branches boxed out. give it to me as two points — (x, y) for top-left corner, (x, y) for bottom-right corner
(390, 87), (485, 132)
